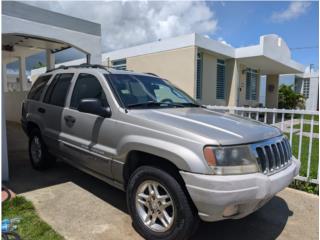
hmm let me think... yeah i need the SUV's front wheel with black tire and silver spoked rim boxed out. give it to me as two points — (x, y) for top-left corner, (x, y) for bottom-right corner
(127, 166), (199, 240)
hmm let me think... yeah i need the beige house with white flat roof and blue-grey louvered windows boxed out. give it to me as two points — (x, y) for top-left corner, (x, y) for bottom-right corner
(32, 34), (304, 108)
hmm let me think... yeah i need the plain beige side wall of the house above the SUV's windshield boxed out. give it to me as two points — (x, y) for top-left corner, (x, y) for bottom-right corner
(110, 46), (196, 97)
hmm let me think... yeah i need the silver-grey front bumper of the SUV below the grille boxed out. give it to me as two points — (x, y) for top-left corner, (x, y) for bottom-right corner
(180, 158), (300, 222)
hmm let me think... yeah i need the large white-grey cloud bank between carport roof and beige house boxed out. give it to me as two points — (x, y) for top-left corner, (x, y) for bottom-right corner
(28, 1), (217, 51)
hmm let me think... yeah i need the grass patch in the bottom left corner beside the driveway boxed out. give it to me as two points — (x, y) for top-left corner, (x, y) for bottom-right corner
(2, 196), (63, 240)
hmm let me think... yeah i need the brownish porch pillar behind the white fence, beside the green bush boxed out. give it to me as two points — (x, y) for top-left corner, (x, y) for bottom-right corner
(266, 75), (279, 122)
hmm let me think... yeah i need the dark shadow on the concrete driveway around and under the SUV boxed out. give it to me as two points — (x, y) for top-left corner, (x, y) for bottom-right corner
(5, 124), (293, 240)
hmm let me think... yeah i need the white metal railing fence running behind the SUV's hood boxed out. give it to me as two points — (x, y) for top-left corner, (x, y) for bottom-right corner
(207, 106), (320, 184)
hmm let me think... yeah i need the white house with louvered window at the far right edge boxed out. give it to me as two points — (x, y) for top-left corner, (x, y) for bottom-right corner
(294, 70), (319, 111)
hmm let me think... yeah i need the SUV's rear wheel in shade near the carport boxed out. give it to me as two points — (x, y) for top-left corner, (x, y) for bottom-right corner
(29, 128), (55, 170)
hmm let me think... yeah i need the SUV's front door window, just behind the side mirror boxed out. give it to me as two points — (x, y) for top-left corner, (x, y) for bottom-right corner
(70, 73), (107, 109)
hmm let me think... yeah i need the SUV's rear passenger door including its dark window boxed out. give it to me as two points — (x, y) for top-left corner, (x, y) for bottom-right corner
(37, 73), (74, 154)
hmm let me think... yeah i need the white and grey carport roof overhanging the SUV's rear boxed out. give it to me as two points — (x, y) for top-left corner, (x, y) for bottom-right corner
(2, 1), (101, 63)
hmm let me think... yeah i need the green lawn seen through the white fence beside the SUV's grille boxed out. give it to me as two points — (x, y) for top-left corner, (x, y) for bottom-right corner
(286, 133), (319, 179)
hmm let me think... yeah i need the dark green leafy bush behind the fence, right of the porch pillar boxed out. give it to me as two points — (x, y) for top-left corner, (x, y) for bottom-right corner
(279, 84), (305, 109)
